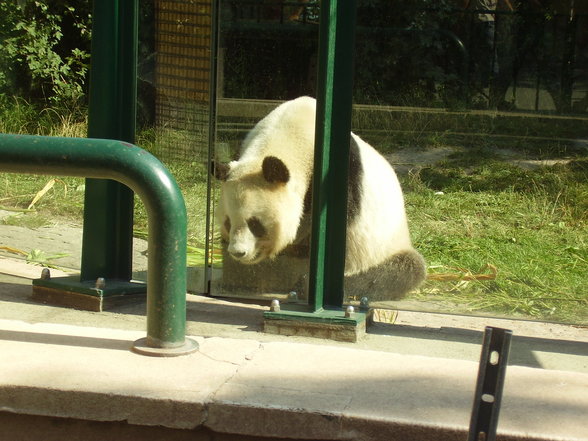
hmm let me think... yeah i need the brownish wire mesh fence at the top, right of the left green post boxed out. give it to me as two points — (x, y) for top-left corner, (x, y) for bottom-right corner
(154, 0), (212, 160)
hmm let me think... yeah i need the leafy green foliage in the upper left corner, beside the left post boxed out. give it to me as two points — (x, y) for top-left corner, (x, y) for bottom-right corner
(0, 0), (90, 106)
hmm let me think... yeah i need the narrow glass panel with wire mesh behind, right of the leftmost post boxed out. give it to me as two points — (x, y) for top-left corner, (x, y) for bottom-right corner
(135, 0), (212, 293)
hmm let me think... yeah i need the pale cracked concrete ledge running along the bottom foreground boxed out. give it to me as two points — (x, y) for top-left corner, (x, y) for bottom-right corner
(0, 320), (588, 441)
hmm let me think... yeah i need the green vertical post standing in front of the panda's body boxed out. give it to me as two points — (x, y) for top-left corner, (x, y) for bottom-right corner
(309, 0), (356, 311)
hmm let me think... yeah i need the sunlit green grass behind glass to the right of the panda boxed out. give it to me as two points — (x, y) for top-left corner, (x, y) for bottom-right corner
(404, 153), (588, 323)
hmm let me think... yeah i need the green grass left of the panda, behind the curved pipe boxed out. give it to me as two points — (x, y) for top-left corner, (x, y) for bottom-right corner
(0, 97), (214, 264)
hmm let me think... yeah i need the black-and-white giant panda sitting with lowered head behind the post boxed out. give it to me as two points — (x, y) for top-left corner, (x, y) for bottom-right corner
(213, 97), (426, 300)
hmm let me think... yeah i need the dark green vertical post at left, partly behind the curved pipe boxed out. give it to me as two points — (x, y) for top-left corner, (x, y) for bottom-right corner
(81, 0), (138, 280)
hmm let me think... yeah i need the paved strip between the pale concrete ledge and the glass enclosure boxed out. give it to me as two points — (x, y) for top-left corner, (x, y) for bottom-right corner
(0, 254), (588, 373)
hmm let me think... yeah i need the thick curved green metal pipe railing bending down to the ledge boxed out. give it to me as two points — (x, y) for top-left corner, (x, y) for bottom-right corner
(0, 134), (186, 348)
